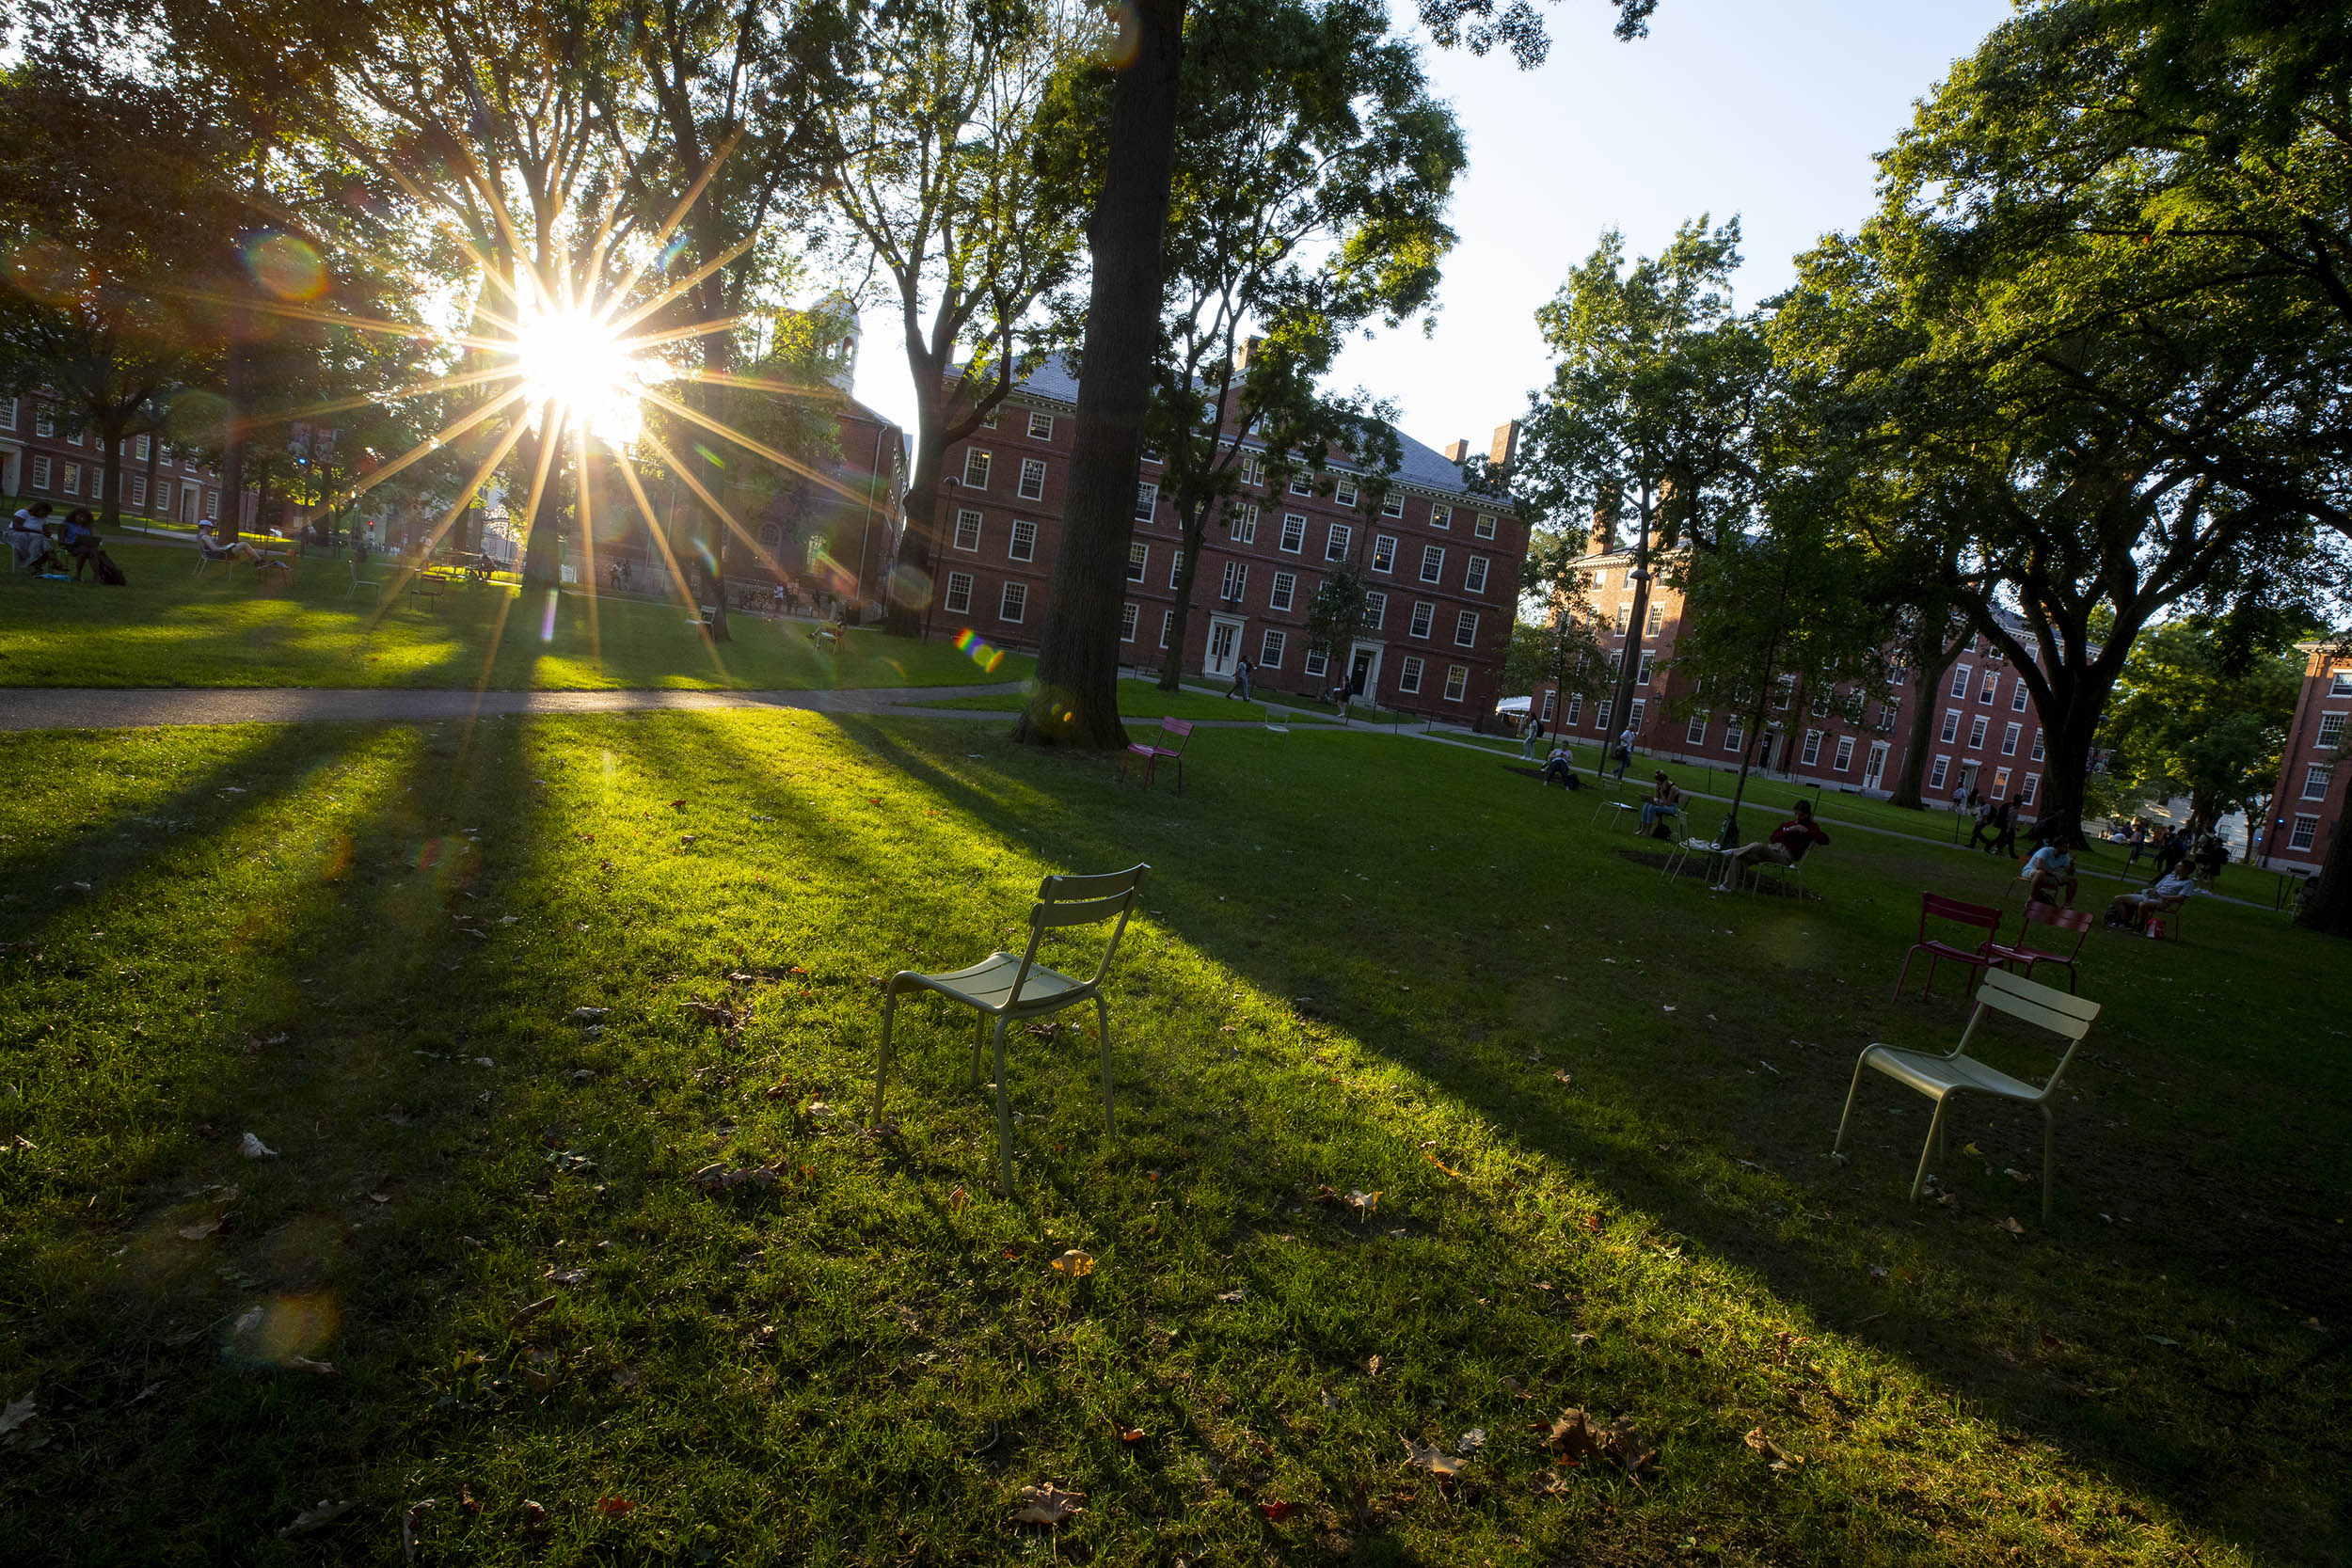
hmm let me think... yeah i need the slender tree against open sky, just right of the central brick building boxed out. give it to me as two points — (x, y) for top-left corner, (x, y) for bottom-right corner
(1518, 216), (1772, 761)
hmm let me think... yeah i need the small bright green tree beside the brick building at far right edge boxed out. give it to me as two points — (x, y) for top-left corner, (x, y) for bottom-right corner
(2098, 616), (2308, 851)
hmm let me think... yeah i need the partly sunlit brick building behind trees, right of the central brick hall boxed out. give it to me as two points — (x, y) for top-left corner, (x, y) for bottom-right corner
(1532, 541), (2046, 811)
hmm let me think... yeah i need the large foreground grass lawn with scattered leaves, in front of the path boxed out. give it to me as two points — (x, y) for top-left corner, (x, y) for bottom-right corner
(0, 712), (2352, 1566)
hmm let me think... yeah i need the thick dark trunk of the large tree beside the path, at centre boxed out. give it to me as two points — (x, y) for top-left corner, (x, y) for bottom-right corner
(1014, 0), (1185, 750)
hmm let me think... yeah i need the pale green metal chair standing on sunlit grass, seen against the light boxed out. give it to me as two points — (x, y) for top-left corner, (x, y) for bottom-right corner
(873, 865), (1152, 1192)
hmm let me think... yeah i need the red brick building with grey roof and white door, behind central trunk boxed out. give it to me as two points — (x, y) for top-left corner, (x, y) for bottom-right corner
(930, 359), (1527, 724)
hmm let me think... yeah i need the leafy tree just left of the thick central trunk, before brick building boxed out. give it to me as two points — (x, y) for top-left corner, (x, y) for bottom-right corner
(823, 0), (1101, 635)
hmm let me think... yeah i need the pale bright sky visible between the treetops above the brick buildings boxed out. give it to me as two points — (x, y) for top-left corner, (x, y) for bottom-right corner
(856, 0), (2011, 451)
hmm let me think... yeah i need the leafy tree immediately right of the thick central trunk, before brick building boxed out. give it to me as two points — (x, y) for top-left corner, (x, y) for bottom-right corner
(1148, 0), (1466, 691)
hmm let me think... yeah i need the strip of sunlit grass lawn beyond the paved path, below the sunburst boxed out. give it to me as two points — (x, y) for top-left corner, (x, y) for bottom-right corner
(0, 536), (1033, 691)
